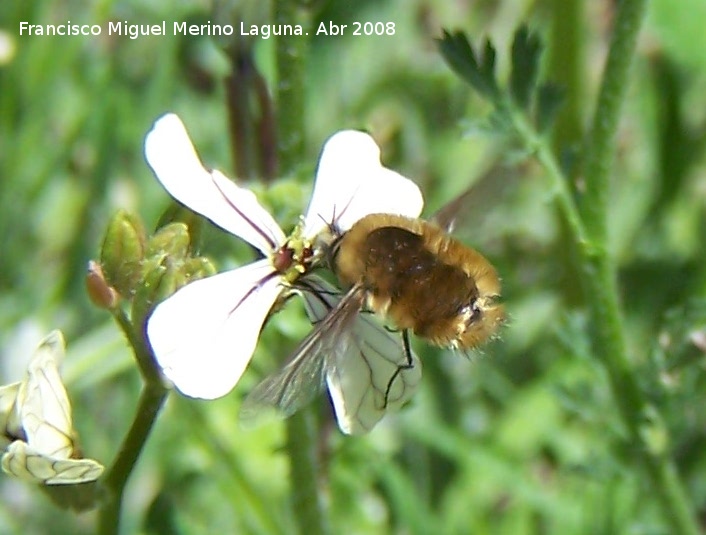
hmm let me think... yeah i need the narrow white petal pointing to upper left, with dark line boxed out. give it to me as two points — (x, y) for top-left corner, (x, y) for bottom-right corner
(145, 113), (284, 253)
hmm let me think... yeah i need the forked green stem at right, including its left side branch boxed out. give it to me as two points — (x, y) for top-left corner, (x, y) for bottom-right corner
(511, 0), (699, 534)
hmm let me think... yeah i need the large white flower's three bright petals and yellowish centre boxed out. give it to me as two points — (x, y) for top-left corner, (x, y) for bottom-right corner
(140, 114), (423, 399)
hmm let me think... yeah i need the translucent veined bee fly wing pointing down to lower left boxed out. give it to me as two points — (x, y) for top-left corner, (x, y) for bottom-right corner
(240, 280), (363, 428)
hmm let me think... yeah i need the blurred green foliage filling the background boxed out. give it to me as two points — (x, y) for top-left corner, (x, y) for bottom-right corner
(0, 0), (706, 534)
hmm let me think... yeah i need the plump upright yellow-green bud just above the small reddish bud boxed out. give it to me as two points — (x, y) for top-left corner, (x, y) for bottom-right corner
(101, 210), (145, 296)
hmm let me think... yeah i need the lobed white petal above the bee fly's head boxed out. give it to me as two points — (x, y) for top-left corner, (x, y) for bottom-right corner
(304, 130), (424, 237)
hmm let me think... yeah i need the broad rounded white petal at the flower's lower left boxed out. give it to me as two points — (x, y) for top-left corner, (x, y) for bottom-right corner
(147, 259), (282, 399)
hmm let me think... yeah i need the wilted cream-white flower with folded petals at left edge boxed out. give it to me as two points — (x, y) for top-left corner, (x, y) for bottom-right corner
(0, 331), (103, 485)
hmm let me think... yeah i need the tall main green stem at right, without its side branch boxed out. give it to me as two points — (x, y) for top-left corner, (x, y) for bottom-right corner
(582, 4), (699, 534)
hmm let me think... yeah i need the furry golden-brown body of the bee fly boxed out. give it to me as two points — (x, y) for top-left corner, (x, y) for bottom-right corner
(334, 214), (503, 348)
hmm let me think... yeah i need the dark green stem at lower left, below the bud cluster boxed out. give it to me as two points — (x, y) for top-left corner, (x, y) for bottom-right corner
(98, 384), (168, 535)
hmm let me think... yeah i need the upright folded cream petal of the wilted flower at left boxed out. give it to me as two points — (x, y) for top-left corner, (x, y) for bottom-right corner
(17, 331), (74, 459)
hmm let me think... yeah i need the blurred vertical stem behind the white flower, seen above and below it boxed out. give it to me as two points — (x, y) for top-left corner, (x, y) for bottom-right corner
(274, 0), (327, 535)
